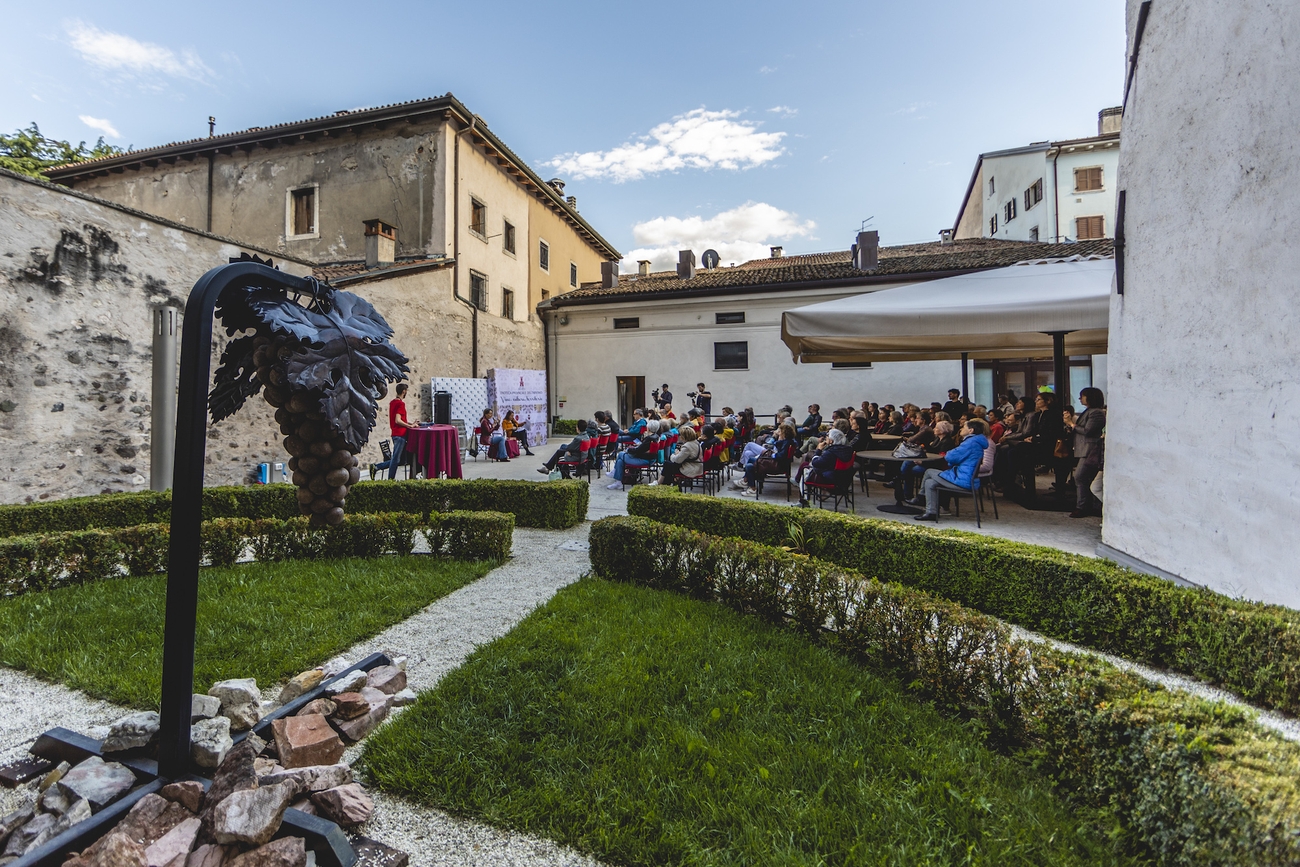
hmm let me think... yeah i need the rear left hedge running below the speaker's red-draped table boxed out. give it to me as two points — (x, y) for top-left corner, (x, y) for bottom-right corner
(0, 478), (589, 537)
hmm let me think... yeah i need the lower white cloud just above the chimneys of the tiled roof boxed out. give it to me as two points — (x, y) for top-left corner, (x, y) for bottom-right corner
(623, 201), (816, 272)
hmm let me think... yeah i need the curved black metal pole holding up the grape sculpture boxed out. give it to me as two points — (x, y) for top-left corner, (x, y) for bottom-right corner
(159, 261), (313, 777)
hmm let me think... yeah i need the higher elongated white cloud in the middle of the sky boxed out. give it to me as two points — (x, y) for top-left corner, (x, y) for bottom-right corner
(545, 108), (785, 183)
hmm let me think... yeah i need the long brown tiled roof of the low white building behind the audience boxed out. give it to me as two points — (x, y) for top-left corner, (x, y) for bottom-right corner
(550, 238), (1114, 307)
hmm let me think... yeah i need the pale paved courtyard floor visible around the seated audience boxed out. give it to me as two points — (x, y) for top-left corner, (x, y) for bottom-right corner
(452, 437), (1101, 556)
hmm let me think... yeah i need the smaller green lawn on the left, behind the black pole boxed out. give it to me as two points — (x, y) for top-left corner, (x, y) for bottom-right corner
(0, 555), (493, 708)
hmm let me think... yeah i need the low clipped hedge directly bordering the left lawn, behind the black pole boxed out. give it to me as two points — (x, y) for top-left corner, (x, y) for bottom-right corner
(0, 512), (515, 597)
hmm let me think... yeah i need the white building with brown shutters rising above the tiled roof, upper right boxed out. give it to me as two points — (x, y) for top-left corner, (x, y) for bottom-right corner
(952, 108), (1122, 243)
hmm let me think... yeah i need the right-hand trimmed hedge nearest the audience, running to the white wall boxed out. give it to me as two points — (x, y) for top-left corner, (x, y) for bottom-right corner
(628, 485), (1300, 714)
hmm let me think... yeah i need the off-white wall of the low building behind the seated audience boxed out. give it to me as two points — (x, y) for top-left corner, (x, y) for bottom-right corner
(549, 285), (961, 419)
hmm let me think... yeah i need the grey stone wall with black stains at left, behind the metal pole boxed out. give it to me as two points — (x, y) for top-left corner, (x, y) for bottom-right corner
(0, 173), (309, 503)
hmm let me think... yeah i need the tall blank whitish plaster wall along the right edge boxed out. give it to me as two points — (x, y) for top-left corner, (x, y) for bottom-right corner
(1102, 0), (1300, 607)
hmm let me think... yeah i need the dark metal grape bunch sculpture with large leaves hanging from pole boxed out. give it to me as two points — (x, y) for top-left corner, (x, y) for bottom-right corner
(208, 260), (410, 526)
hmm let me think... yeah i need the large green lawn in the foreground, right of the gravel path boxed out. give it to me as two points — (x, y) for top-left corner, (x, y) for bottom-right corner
(364, 578), (1138, 866)
